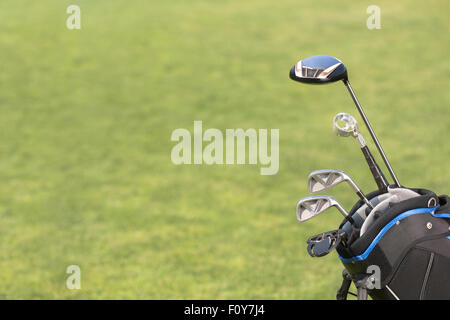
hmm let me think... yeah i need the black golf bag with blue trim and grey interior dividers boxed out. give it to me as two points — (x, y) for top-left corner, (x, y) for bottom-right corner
(336, 189), (450, 300)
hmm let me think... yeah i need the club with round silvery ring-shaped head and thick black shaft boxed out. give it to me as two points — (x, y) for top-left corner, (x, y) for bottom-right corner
(333, 113), (389, 193)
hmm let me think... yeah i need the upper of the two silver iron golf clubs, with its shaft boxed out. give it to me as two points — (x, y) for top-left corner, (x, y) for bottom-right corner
(308, 169), (373, 209)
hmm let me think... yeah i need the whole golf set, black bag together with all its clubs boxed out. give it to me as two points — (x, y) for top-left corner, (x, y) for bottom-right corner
(289, 55), (450, 300)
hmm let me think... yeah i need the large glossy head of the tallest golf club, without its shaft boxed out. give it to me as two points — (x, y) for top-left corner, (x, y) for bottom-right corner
(289, 55), (348, 84)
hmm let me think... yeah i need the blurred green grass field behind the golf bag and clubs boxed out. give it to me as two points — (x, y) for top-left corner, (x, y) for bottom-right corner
(0, 0), (450, 299)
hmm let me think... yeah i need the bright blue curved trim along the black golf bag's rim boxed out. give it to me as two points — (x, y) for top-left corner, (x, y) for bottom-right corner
(338, 205), (450, 263)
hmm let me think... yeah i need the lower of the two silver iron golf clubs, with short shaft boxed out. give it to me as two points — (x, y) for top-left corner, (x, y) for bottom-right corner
(297, 196), (354, 224)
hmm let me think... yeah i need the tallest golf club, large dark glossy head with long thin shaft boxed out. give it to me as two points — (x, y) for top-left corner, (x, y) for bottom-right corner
(289, 55), (400, 187)
